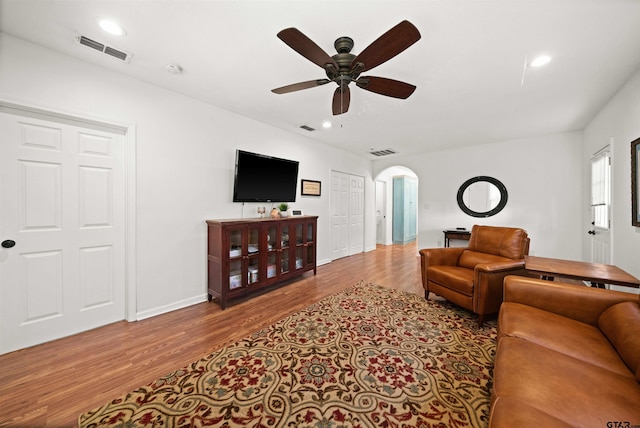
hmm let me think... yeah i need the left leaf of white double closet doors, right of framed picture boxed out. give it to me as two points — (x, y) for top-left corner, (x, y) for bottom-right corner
(331, 171), (349, 260)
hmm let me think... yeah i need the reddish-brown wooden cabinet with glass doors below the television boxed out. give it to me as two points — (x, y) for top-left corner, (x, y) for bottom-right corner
(207, 217), (318, 309)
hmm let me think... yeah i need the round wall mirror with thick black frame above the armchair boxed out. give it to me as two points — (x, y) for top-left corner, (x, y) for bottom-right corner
(458, 176), (508, 217)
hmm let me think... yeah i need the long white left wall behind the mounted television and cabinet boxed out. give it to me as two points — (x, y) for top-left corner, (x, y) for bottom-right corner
(0, 34), (375, 317)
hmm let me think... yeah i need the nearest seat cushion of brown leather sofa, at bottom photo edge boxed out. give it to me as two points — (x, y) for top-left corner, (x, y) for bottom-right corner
(489, 397), (573, 428)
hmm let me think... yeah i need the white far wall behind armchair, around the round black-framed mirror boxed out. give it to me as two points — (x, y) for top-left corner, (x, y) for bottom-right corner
(373, 132), (583, 260)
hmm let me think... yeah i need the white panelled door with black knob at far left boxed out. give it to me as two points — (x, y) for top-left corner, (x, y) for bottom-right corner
(0, 112), (125, 353)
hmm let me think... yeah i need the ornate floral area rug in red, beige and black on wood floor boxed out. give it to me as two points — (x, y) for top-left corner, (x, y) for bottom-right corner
(78, 282), (496, 428)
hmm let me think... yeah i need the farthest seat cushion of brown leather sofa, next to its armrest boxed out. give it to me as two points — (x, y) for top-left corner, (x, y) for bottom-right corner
(498, 302), (637, 378)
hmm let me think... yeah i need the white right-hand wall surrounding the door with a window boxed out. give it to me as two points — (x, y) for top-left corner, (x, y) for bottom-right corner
(582, 71), (640, 291)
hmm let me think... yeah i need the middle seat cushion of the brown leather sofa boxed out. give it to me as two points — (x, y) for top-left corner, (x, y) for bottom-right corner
(493, 336), (640, 427)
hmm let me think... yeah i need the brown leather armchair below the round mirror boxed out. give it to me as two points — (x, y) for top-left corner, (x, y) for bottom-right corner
(420, 225), (529, 327)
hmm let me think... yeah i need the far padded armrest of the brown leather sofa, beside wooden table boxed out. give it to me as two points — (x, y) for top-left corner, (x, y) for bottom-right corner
(504, 276), (638, 326)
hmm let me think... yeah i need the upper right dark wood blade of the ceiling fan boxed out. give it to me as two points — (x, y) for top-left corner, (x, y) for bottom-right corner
(351, 21), (420, 72)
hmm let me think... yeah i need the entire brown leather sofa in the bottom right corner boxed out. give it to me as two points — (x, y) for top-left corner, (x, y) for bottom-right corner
(489, 276), (640, 428)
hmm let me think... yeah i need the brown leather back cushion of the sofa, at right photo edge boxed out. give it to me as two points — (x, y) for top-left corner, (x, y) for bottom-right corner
(598, 302), (640, 382)
